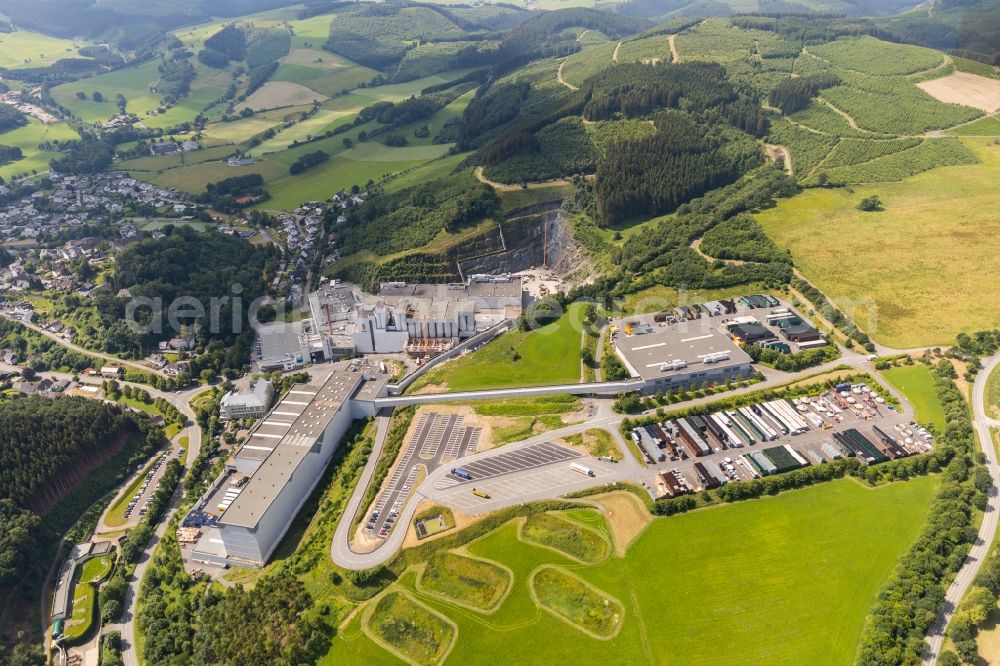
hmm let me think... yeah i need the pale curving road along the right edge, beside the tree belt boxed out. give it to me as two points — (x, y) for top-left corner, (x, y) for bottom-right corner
(923, 354), (1000, 666)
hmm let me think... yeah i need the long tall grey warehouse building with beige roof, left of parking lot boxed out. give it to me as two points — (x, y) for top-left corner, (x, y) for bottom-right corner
(189, 370), (386, 567)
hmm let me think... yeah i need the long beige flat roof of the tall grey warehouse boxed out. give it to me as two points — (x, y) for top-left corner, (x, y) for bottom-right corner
(219, 372), (364, 527)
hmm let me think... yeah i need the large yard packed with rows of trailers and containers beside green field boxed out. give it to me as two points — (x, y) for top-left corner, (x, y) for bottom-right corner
(630, 385), (932, 496)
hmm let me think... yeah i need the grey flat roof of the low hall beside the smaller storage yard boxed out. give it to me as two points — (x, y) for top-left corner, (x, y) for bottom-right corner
(615, 316), (753, 380)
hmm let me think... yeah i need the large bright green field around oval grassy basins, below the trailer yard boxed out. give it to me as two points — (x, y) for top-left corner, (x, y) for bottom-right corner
(321, 477), (936, 666)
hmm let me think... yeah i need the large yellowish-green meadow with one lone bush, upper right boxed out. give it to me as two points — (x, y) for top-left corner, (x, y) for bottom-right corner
(757, 134), (1000, 348)
